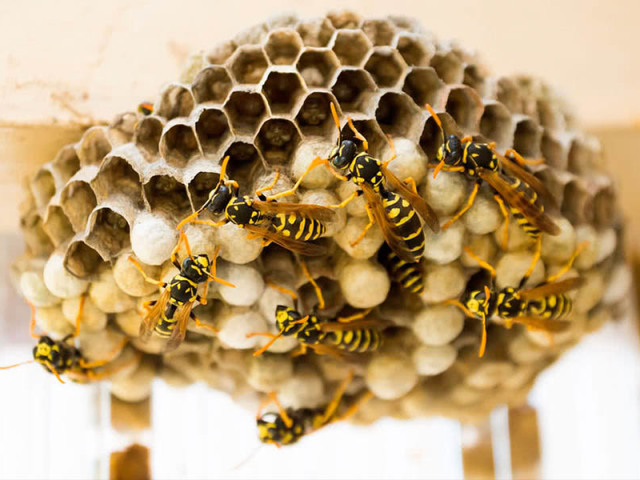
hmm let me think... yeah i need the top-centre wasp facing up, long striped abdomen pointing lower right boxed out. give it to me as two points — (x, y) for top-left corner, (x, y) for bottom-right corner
(268, 103), (440, 263)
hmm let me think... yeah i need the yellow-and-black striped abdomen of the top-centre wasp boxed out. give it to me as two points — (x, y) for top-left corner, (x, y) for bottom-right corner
(382, 192), (425, 262)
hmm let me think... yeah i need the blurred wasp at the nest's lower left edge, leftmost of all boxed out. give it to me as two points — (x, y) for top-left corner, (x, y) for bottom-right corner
(0, 296), (139, 383)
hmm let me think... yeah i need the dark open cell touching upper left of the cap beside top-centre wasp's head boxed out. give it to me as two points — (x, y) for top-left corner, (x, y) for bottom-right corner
(256, 118), (300, 165)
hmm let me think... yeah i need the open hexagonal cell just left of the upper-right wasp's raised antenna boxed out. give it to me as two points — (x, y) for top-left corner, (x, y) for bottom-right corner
(376, 92), (422, 138)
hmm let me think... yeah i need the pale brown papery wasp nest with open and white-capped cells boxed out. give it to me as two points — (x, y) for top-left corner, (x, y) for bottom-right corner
(17, 12), (629, 421)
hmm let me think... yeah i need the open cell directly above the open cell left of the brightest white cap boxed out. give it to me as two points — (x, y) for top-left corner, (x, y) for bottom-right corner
(91, 156), (143, 208)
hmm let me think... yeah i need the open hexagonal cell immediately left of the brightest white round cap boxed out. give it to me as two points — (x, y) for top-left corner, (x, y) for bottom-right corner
(87, 207), (130, 258)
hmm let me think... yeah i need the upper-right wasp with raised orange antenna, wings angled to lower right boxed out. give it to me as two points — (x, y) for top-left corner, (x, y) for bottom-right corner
(426, 104), (560, 276)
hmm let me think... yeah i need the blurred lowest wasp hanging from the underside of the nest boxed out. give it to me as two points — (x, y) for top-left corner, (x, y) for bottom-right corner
(256, 371), (372, 447)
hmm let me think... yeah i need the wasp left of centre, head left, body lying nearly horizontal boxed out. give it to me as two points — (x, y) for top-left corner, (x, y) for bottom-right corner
(178, 156), (335, 256)
